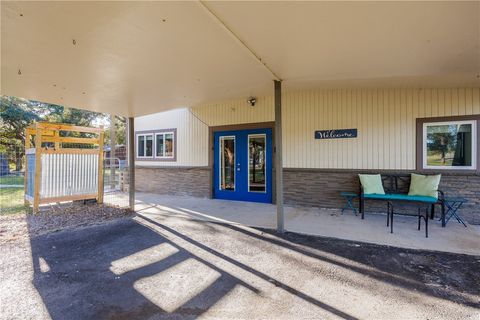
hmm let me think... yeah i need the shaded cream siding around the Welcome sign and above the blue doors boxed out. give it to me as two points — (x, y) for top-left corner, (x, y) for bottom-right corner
(192, 88), (480, 170)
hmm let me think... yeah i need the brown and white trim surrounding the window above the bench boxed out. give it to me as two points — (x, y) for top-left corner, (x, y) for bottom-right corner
(416, 114), (480, 173)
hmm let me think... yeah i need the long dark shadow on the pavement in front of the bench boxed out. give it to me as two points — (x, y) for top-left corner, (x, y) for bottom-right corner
(169, 207), (480, 308)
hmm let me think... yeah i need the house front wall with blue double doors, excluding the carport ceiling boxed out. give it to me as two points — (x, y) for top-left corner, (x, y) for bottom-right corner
(135, 87), (480, 223)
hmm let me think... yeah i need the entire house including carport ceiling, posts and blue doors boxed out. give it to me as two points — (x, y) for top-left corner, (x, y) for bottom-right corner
(1, 1), (480, 231)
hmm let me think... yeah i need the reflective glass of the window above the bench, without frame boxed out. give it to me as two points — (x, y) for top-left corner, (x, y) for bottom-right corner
(427, 123), (473, 167)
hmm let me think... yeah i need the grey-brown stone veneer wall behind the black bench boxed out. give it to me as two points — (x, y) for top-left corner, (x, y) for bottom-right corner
(283, 168), (480, 224)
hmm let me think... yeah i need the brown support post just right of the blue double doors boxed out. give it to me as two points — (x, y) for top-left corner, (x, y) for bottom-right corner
(273, 80), (285, 233)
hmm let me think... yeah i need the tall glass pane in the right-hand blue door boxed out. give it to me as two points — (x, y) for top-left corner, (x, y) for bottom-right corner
(248, 134), (266, 192)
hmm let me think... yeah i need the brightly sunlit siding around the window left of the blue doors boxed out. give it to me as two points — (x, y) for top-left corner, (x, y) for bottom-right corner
(135, 108), (208, 167)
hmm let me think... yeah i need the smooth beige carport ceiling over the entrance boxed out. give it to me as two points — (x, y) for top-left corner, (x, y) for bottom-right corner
(1, 1), (480, 116)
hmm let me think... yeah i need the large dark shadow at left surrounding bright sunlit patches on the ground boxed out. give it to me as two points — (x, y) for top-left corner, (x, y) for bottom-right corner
(31, 220), (262, 319)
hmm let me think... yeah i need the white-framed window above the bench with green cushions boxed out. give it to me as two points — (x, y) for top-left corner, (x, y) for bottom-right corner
(422, 120), (477, 170)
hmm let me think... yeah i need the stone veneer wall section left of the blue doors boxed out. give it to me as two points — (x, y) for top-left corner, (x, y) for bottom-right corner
(135, 167), (211, 198)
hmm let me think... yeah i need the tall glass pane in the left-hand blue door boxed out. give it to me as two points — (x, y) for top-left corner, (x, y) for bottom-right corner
(219, 137), (235, 190)
